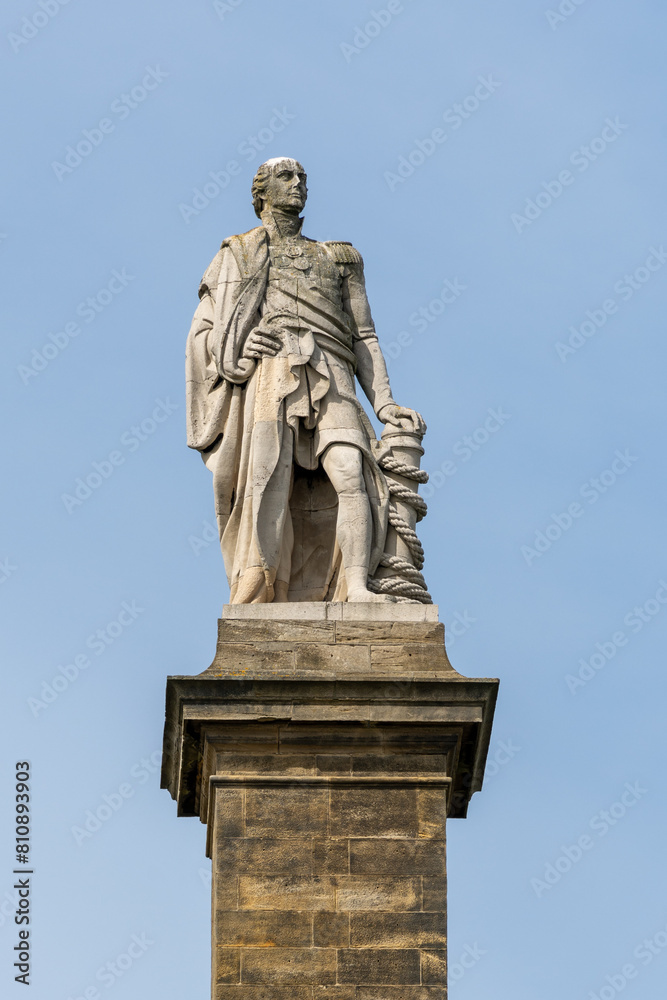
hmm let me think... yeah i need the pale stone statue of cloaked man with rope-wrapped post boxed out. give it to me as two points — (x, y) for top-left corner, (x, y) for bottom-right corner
(186, 157), (431, 604)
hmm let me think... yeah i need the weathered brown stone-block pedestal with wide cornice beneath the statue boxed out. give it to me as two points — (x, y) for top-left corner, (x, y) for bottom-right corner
(163, 604), (498, 1000)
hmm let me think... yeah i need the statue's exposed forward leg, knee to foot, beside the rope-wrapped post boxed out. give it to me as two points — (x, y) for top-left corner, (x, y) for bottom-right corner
(321, 444), (393, 604)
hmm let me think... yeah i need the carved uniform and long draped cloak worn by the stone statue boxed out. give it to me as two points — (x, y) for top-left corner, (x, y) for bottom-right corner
(186, 226), (393, 603)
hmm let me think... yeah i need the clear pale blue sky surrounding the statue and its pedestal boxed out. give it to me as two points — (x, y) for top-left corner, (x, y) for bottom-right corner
(0, 0), (667, 1000)
